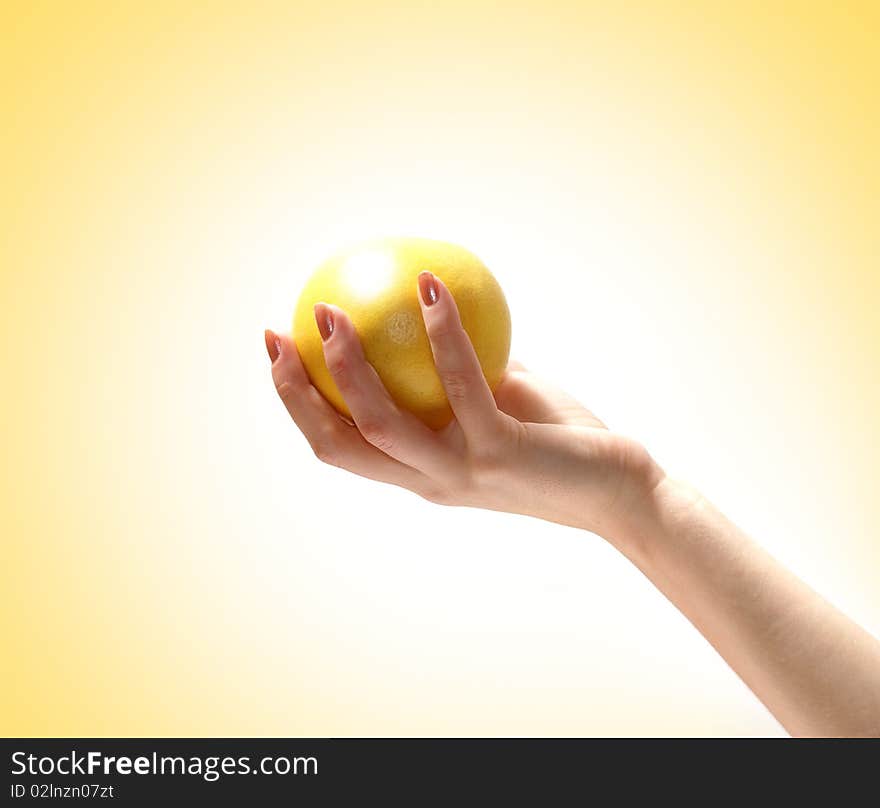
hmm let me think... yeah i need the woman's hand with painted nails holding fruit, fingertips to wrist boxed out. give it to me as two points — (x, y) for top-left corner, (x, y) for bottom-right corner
(266, 272), (663, 537)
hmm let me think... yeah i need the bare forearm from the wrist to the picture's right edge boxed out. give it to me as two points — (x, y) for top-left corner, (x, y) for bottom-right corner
(607, 479), (880, 736)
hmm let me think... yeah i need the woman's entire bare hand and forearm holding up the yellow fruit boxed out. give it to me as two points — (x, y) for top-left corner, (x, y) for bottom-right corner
(266, 273), (880, 736)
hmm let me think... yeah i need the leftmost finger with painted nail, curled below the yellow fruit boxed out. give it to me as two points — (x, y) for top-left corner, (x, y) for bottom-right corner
(266, 331), (430, 495)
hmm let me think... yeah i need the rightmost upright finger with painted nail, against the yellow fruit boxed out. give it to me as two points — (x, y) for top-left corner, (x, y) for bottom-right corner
(419, 272), (498, 437)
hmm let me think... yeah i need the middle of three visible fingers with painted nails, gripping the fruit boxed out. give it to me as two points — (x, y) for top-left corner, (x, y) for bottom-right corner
(315, 303), (452, 479)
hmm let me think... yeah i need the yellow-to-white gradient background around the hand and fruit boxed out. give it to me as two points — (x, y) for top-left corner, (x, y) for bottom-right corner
(0, 0), (880, 736)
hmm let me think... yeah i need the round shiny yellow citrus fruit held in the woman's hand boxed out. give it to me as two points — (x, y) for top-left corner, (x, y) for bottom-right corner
(293, 238), (510, 429)
